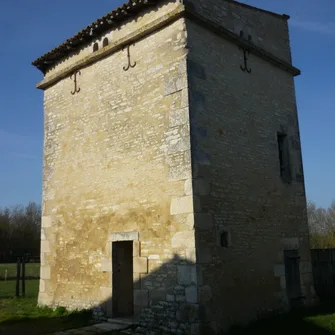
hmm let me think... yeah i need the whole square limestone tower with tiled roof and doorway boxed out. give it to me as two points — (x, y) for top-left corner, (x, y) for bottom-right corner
(33, 0), (315, 334)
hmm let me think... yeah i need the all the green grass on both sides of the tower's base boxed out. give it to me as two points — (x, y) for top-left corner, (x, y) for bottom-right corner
(0, 280), (335, 335)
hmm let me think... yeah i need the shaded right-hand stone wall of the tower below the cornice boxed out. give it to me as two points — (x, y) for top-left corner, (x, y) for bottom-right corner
(187, 20), (313, 334)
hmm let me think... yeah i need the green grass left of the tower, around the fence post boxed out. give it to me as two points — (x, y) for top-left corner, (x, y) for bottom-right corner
(0, 280), (92, 335)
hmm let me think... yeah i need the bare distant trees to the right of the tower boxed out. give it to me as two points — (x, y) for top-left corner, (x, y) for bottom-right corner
(307, 201), (335, 249)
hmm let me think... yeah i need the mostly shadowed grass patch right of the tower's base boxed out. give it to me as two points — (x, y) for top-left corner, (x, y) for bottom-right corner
(228, 303), (335, 335)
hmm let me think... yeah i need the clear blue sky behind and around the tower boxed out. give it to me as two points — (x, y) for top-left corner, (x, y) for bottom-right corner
(0, 0), (335, 207)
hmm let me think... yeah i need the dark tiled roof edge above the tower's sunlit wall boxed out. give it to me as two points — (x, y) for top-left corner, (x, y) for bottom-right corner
(32, 0), (161, 73)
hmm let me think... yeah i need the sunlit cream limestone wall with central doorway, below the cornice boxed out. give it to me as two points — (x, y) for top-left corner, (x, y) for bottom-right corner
(39, 12), (201, 330)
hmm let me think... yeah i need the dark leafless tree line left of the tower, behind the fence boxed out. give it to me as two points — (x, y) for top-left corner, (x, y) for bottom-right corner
(0, 202), (41, 263)
